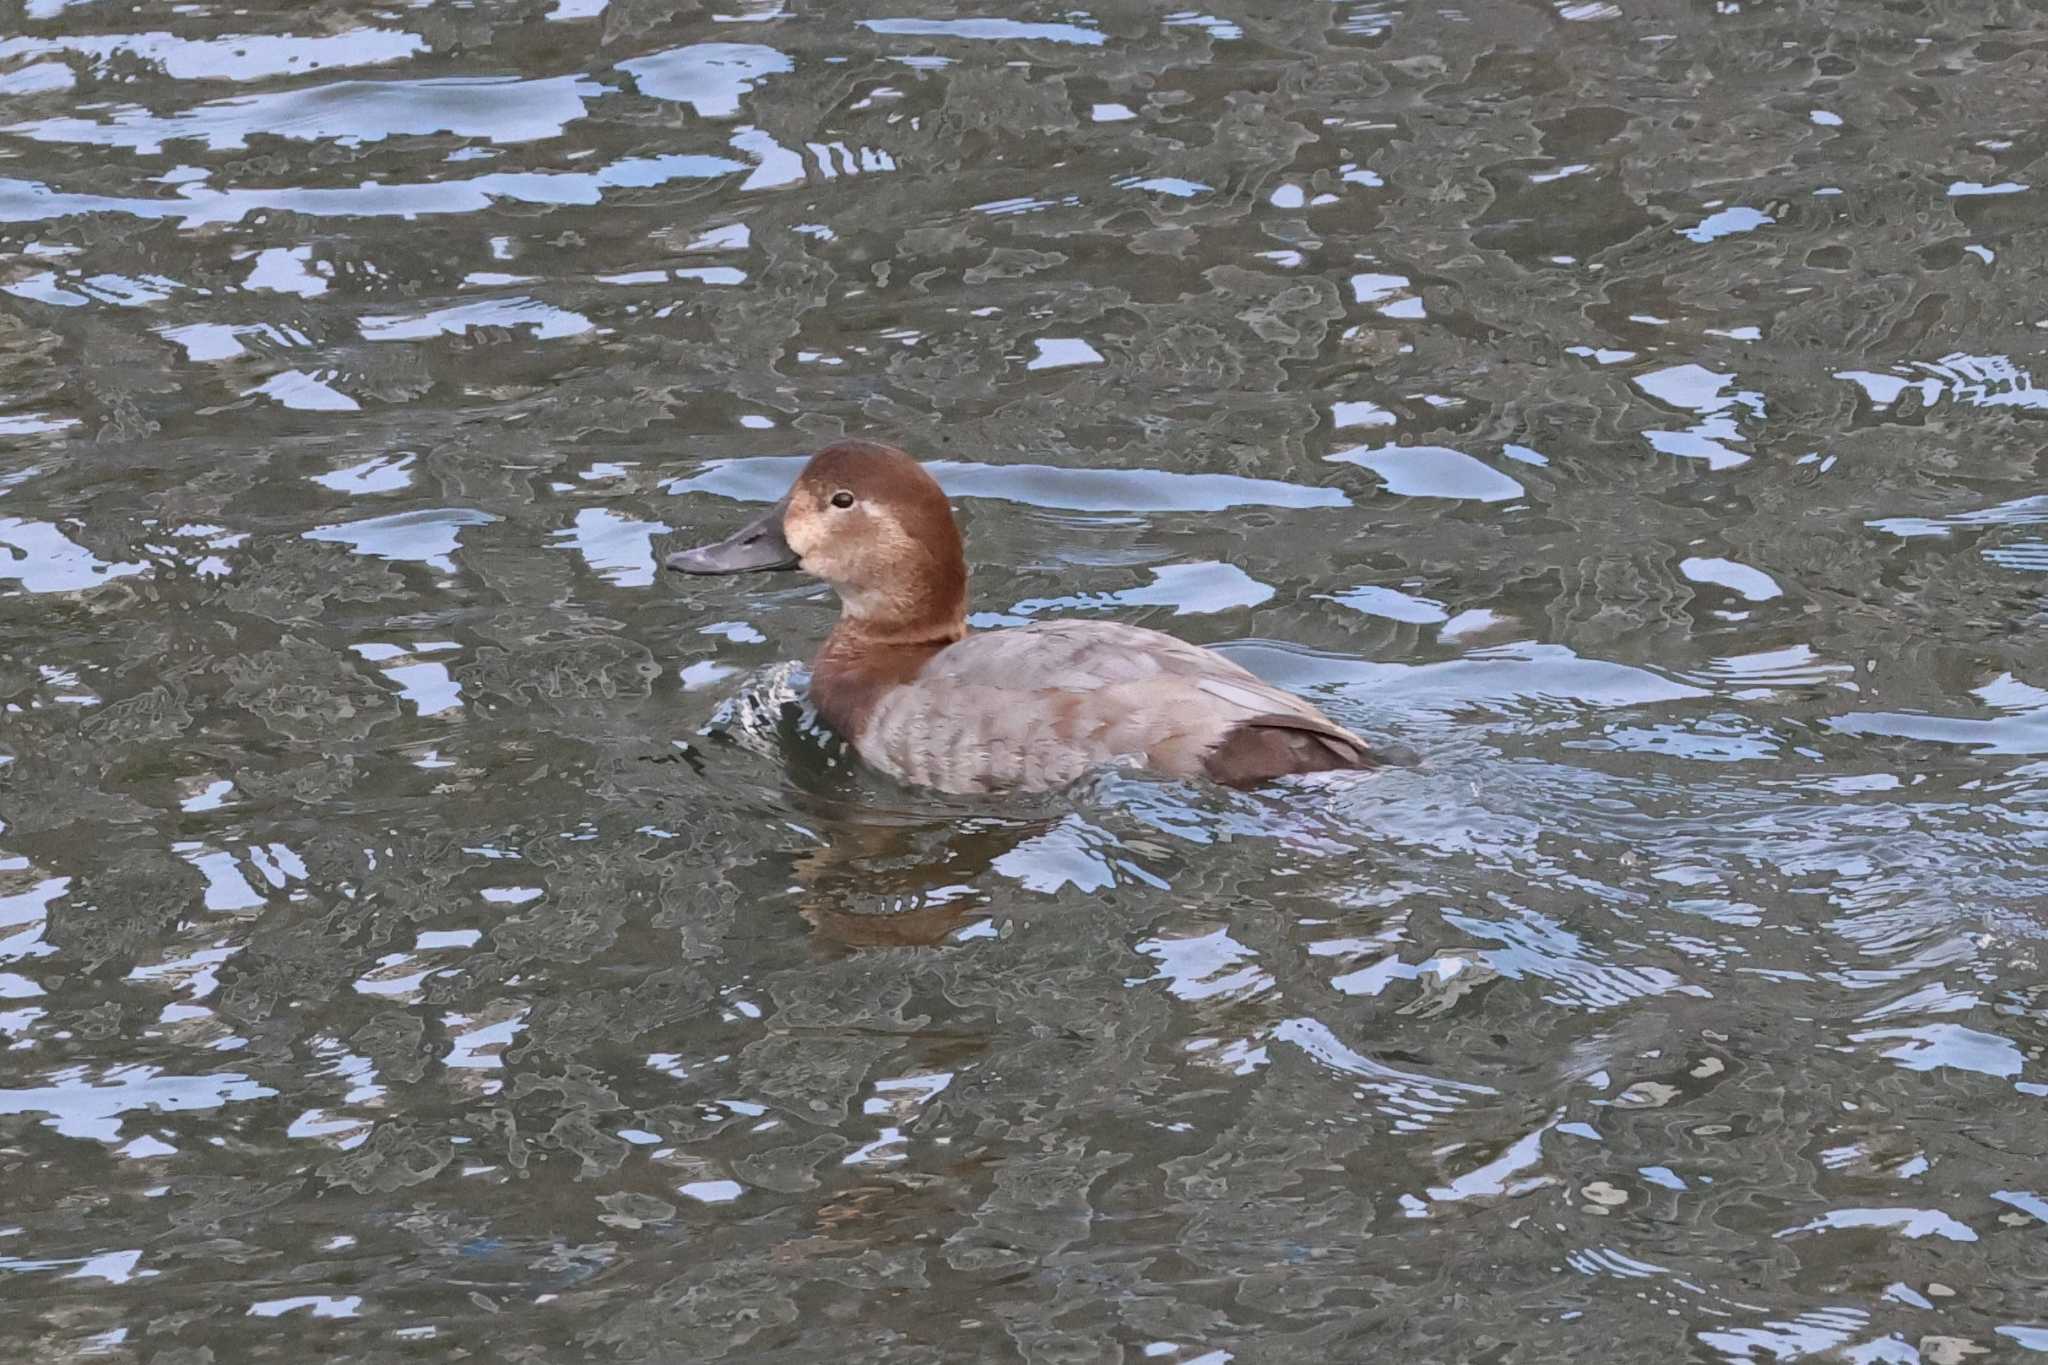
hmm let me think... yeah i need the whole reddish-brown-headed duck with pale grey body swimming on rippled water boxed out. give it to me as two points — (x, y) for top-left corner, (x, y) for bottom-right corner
(666, 440), (1386, 796)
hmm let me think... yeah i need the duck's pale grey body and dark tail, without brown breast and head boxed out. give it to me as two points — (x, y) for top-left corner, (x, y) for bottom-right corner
(856, 620), (1380, 792)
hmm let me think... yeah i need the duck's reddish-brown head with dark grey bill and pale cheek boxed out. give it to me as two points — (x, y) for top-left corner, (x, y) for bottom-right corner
(668, 440), (967, 639)
